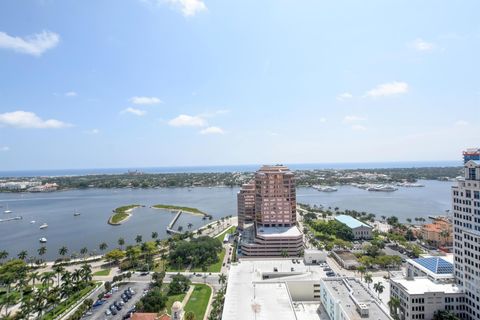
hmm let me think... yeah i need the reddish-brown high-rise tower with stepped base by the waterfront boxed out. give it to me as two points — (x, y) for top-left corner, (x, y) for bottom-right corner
(237, 165), (303, 256)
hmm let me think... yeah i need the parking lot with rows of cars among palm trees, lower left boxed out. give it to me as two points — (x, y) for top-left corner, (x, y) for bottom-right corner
(85, 283), (148, 320)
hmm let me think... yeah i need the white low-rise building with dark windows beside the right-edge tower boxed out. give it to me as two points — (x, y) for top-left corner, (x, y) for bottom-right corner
(390, 277), (465, 320)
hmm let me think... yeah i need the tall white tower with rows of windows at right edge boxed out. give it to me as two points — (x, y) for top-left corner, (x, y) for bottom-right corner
(452, 149), (480, 319)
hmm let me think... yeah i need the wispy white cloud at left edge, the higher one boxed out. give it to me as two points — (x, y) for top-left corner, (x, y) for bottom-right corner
(0, 31), (60, 57)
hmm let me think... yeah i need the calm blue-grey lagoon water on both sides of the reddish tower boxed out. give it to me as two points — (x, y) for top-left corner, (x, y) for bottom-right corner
(0, 181), (452, 259)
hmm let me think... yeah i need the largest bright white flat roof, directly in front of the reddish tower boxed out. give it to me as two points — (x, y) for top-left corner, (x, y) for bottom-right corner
(222, 258), (336, 320)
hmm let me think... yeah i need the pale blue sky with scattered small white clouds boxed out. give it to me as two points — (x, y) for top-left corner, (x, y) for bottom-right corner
(0, 0), (480, 170)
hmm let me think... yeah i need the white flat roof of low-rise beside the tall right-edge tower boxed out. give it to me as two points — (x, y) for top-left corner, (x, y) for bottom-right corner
(390, 277), (461, 294)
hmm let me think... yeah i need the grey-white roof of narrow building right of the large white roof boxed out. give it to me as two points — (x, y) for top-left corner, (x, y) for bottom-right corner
(322, 278), (391, 320)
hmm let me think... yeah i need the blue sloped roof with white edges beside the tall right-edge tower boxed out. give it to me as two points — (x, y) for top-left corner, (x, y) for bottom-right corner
(407, 255), (454, 283)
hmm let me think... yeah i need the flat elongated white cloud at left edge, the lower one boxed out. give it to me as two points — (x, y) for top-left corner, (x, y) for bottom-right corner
(0, 110), (72, 129)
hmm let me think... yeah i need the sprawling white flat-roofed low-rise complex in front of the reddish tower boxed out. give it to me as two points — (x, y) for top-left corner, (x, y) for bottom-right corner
(222, 258), (392, 320)
